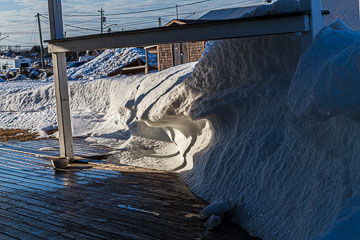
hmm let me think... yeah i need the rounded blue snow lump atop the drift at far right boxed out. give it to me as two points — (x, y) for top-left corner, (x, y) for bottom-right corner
(288, 20), (360, 120)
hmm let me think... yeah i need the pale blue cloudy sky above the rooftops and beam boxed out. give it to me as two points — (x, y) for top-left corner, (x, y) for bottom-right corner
(0, 0), (265, 46)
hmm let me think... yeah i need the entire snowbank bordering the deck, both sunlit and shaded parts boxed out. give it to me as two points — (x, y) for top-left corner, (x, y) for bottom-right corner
(0, 1), (360, 240)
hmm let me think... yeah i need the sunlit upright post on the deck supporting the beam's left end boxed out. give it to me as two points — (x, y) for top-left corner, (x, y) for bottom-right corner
(48, 0), (74, 161)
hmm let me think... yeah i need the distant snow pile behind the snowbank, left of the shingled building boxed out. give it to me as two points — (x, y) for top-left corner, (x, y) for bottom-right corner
(67, 48), (157, 80)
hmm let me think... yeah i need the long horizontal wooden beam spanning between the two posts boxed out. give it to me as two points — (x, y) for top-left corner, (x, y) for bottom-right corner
(47, 11), (310, 53)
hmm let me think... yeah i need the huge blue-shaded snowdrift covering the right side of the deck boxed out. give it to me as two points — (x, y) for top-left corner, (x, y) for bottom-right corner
(177, 22), (360, 239)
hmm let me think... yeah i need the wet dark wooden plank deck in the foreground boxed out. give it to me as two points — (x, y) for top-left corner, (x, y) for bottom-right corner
(0, 140), (255, 240)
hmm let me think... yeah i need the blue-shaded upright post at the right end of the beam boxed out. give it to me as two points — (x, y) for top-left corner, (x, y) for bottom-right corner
(300, 0), (324, 52)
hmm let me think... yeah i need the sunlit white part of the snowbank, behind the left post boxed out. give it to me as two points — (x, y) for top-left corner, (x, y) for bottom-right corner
(0, 63), (200, 170)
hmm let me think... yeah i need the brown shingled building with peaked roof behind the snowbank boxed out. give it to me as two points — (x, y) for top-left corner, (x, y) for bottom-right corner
(157, 19), (206, 71)
